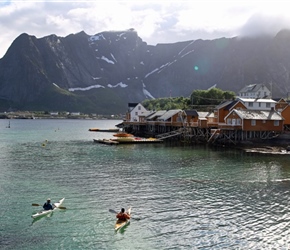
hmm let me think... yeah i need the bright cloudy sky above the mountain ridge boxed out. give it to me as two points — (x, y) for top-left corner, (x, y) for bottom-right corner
(0, 0), (290, 58)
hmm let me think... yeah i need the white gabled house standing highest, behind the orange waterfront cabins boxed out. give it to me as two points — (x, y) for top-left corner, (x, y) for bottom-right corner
(238, 84), (272, 99)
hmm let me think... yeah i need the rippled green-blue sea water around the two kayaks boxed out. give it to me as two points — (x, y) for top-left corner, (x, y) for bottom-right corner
(0, 119), (290, 250)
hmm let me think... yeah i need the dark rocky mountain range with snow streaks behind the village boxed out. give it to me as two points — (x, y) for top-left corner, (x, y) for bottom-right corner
(0, 29), (290, 114)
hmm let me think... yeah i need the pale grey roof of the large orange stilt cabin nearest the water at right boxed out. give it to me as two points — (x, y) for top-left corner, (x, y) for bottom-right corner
(227, 109), (283, 121)
